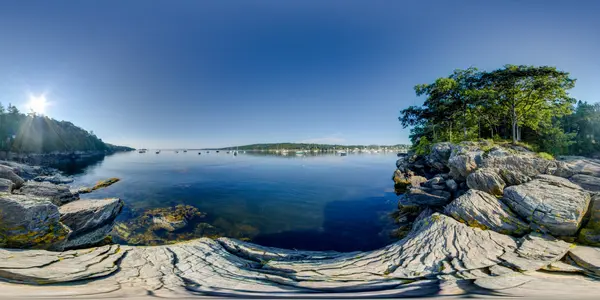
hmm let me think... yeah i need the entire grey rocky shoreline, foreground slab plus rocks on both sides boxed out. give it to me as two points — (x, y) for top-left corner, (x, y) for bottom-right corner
(0, 142), (600, 299)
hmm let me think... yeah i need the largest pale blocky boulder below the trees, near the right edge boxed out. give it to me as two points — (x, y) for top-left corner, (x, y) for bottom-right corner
(503, 175), (590, 236)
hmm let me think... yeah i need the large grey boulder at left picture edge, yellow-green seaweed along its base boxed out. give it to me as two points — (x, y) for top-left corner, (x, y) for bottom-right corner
(0, 193), (71, 250)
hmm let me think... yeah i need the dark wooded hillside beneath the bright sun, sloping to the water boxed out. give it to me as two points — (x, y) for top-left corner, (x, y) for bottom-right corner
(0, 103), (133, 153)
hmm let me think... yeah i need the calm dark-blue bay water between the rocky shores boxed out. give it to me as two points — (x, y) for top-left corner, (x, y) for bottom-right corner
(64, 151), (397, 251)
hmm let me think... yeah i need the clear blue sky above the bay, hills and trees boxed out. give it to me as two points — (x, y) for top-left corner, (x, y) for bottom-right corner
(0, 0), (600, 148)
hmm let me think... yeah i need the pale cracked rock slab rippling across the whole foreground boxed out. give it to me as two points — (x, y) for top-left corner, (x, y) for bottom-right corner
(0, 213), (598, 298)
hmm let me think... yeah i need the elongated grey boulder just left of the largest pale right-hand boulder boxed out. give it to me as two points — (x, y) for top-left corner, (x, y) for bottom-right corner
(444, 190), (529, 236)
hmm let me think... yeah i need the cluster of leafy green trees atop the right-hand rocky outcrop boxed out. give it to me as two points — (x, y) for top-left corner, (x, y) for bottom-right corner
(398, 65), (600, 155)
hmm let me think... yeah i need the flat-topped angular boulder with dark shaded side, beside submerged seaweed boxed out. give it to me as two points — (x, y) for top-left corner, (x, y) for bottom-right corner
(59, 198), (123, 237)
